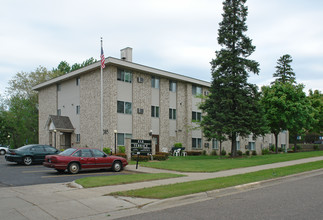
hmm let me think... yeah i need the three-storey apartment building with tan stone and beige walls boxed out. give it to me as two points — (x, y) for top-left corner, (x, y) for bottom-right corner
(33, 47), (288, 153)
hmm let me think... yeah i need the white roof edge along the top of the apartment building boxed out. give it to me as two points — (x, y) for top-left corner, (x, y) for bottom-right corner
(32, 57), (211, 91)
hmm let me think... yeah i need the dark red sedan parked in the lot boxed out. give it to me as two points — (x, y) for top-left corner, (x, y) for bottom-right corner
(43, 148), (128, 174)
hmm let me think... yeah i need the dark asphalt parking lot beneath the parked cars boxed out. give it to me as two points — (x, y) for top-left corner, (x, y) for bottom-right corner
(0, 155), (129, 187)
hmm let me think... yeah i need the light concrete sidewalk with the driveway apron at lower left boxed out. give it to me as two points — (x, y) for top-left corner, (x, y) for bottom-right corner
(0, 157), (323, 220)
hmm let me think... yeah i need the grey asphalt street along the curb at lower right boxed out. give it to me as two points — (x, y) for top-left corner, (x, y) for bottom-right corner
(121, 171), (323, 220)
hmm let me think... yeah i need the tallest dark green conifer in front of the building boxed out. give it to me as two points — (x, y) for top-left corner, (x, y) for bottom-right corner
(200, 0), (267, 157)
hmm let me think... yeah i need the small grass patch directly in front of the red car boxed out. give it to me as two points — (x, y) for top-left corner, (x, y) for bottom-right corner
(75, 173), (185, 188)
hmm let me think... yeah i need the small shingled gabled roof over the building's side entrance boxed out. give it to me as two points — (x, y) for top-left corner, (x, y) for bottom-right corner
(46, 115), (75, 133)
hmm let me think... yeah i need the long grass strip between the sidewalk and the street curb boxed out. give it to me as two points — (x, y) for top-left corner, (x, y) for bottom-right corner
(110, 161), (323, 199)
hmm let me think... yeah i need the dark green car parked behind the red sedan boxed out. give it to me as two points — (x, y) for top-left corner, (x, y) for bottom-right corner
(5, 144), (59, 166)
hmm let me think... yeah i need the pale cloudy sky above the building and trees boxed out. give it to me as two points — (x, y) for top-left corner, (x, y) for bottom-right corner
(0, 0), (323, 96)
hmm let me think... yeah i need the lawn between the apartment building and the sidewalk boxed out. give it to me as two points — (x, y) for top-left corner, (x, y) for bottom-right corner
(139, 151), (323, 172)
